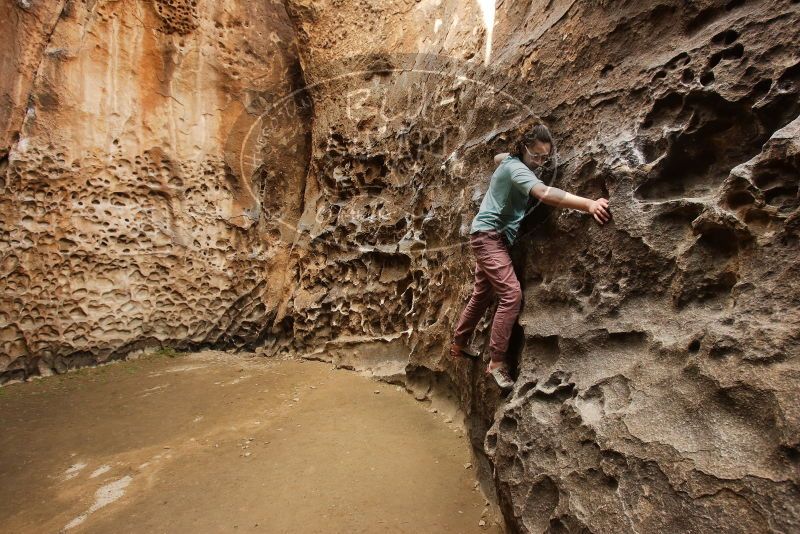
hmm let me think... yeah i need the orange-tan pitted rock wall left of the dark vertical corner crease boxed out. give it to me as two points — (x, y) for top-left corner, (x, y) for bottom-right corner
(0, 0), (310, 380)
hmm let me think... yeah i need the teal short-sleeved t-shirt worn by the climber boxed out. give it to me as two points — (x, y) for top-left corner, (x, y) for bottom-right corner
(469, 156), (542, 243)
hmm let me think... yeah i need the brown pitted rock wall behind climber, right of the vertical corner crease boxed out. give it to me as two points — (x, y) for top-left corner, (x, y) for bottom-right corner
(282, 1), (800, 532)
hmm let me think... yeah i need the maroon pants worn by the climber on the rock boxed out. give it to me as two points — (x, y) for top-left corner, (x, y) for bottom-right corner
(453, 230), (522, 362)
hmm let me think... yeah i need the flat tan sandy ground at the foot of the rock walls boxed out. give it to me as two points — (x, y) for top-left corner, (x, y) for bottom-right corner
(0, 351), (499, 533)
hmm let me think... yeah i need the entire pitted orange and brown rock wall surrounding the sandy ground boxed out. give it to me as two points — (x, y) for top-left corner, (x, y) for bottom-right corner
(0, 0), (800, 534)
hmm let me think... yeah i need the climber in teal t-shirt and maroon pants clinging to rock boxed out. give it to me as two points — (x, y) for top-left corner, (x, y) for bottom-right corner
(450, 124), (610, 389)
